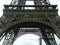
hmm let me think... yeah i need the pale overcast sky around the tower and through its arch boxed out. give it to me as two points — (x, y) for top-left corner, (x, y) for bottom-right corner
(0, 0), (60, 45)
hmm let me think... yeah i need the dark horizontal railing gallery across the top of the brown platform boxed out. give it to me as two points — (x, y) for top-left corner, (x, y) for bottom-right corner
(4, 5), (57, 10)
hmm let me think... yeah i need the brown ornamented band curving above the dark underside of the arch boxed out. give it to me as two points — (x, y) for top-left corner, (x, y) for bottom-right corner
(0, 18), (59, 34)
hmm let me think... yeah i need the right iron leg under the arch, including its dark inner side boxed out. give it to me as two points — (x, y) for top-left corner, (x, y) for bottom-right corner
(41, 29), (57, 45)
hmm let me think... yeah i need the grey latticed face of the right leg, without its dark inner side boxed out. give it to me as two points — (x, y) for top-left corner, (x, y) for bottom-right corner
(45, 29), (57, 45)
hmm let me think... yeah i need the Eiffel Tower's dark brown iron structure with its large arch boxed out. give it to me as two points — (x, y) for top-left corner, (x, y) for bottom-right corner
(0, 0), (60, 45)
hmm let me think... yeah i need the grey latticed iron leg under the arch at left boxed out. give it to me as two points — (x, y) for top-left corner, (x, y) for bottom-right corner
(2, 30), (15, 45)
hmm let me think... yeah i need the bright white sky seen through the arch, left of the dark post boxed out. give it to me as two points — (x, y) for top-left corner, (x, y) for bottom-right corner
(13, 34), (39, 45)
